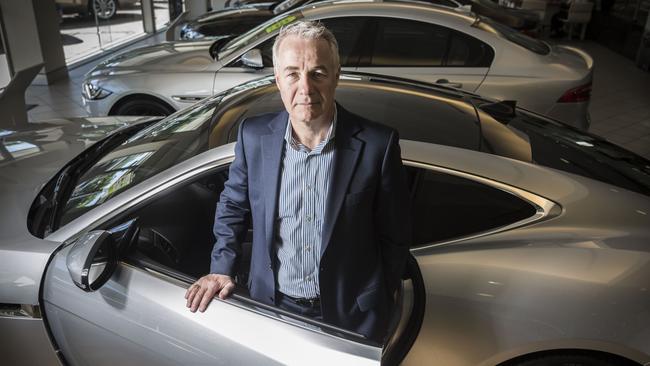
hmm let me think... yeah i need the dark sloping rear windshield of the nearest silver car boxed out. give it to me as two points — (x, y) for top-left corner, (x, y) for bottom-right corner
(476, 101), (650, 195)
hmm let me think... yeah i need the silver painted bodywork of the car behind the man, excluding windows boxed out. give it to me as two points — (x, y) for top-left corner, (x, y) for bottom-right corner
(84, 1), (593, 129)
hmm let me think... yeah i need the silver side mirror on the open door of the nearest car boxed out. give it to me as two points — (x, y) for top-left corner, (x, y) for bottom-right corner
(66, 230), (117, 292)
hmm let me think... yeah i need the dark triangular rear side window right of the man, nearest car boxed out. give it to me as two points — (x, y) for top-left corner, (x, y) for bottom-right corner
(407, 167), (537, 247)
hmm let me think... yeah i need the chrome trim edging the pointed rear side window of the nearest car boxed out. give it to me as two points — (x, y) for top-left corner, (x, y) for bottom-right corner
(403, 159), (562, 253)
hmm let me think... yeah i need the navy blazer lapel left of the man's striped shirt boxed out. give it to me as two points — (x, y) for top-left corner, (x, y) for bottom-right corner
(260, 112), (289, 255)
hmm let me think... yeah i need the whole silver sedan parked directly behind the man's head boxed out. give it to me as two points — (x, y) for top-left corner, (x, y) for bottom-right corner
(82, 1), (593, 129)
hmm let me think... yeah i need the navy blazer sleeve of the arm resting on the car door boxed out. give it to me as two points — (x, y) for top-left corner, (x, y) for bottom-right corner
(210, 121), (250, 276)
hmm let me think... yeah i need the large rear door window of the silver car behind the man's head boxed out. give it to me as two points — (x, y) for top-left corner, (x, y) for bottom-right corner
(370, 18), (450, 67)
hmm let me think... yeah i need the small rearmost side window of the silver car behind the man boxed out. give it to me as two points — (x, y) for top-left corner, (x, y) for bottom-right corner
(446, 31), (494, 67)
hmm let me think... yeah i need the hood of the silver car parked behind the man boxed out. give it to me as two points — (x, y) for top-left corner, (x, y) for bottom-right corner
(86, 39), (214, 77)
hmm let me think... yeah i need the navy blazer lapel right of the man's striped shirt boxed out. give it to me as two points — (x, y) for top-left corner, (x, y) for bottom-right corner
(321, 104), (363, 256)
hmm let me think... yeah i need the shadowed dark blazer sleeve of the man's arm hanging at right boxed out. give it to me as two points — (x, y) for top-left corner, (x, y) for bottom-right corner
(375, 131), (412, 294)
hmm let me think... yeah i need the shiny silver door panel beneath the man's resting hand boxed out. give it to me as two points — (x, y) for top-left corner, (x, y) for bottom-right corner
(43, 246), (381, 365)
